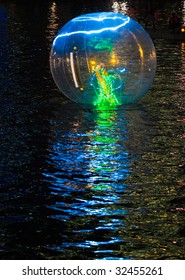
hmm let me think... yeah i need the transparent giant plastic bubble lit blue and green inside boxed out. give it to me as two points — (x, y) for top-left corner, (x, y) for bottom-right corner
(50, 12), (156, 106)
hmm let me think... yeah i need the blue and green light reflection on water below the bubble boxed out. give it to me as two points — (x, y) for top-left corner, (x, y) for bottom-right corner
(44, 107), (130, 257)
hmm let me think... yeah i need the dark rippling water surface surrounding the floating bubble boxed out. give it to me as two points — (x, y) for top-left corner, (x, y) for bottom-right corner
(0, 0), (185, 259)
